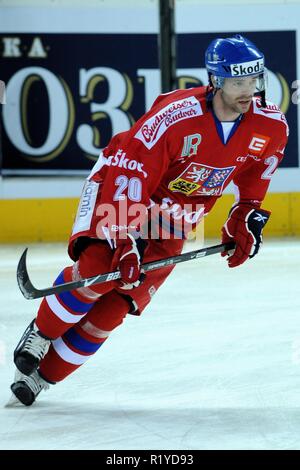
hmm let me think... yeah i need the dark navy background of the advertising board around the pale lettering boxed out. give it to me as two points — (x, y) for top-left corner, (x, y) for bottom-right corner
(0, 31), (299, 174)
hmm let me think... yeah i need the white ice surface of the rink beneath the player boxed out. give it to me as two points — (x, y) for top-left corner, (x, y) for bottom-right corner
(0, 239), (300, 450)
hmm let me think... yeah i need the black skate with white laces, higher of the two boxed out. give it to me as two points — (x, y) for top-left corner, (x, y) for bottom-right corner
(14, 320), (51, 375)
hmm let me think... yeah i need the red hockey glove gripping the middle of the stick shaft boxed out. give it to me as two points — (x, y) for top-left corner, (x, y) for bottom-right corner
(112, 234), (147, 290)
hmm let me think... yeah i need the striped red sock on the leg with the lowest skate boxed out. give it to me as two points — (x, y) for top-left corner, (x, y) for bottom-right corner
(40, 291), (129, 382)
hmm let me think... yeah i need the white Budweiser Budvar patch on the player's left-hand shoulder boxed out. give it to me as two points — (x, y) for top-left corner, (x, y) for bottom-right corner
(135, 96), (203, 150)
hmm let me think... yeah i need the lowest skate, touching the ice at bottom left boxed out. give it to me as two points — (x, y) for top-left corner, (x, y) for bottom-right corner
(7, 370), (49, 406)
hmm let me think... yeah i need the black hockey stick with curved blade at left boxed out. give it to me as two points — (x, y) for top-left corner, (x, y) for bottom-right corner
(17, 242), (235, 299)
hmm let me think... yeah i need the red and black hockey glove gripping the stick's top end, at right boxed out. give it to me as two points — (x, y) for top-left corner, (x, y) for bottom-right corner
(222, 204), (271, 268)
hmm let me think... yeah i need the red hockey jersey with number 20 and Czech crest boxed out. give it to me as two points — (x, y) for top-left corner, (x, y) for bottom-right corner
(71, 87), (288, 253)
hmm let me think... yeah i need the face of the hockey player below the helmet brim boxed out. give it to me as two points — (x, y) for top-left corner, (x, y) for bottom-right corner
(221, 76), (257, 114)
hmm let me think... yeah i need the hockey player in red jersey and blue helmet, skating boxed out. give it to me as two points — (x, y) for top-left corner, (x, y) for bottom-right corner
(11, 35), (288, 405)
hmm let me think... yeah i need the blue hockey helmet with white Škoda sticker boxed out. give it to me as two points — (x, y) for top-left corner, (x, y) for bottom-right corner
(205, 34), (265, 91)
